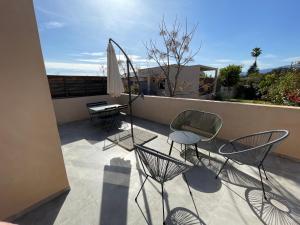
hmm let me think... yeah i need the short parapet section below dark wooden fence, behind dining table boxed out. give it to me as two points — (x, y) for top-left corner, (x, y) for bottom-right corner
(53, 95), (117, 124)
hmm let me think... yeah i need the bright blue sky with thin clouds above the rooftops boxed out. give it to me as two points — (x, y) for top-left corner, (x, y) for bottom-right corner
(34, 0), (300, 76)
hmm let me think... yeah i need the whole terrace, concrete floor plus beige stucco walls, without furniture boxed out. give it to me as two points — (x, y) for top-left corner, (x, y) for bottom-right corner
(0, 0), (300, 225)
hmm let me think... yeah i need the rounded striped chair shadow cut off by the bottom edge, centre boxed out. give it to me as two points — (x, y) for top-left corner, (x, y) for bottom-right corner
(165, 207), (205, 225)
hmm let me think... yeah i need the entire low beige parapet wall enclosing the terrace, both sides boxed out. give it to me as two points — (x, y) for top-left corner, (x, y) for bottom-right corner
(53, 94), (300, 160)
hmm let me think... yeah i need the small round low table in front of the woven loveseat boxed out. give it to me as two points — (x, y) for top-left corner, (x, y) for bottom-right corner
(169, 131), (201, 159)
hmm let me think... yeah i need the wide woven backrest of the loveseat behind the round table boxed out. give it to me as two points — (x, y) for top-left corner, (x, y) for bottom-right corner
(170, 110), (222, 138)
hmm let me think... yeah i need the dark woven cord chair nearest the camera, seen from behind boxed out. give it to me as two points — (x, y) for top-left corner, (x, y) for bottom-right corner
(135, 144), (192, 224)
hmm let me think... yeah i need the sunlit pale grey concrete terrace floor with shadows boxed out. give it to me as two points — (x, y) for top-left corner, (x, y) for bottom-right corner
(15, 119), (300, 225)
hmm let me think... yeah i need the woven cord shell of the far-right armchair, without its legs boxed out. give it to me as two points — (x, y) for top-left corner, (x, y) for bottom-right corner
(220, 130), (289, 165)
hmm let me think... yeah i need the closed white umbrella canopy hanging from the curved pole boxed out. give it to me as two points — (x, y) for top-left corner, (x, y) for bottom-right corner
(107, 42), (124, 97)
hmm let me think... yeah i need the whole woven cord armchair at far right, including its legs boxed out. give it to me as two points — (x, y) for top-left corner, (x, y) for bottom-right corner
(216, 130), (289, 200)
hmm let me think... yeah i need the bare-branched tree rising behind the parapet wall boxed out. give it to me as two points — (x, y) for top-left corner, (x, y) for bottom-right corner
(145, 18), (200, 97)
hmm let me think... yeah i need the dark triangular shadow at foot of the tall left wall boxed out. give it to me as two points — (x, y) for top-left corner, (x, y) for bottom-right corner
(14, 191), (69, 225)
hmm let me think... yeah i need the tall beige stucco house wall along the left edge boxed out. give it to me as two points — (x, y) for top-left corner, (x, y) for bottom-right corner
(0, 0), (69, 220)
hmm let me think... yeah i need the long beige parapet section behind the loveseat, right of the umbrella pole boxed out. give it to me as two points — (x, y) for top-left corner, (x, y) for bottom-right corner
(120, 95), (300, 159)
